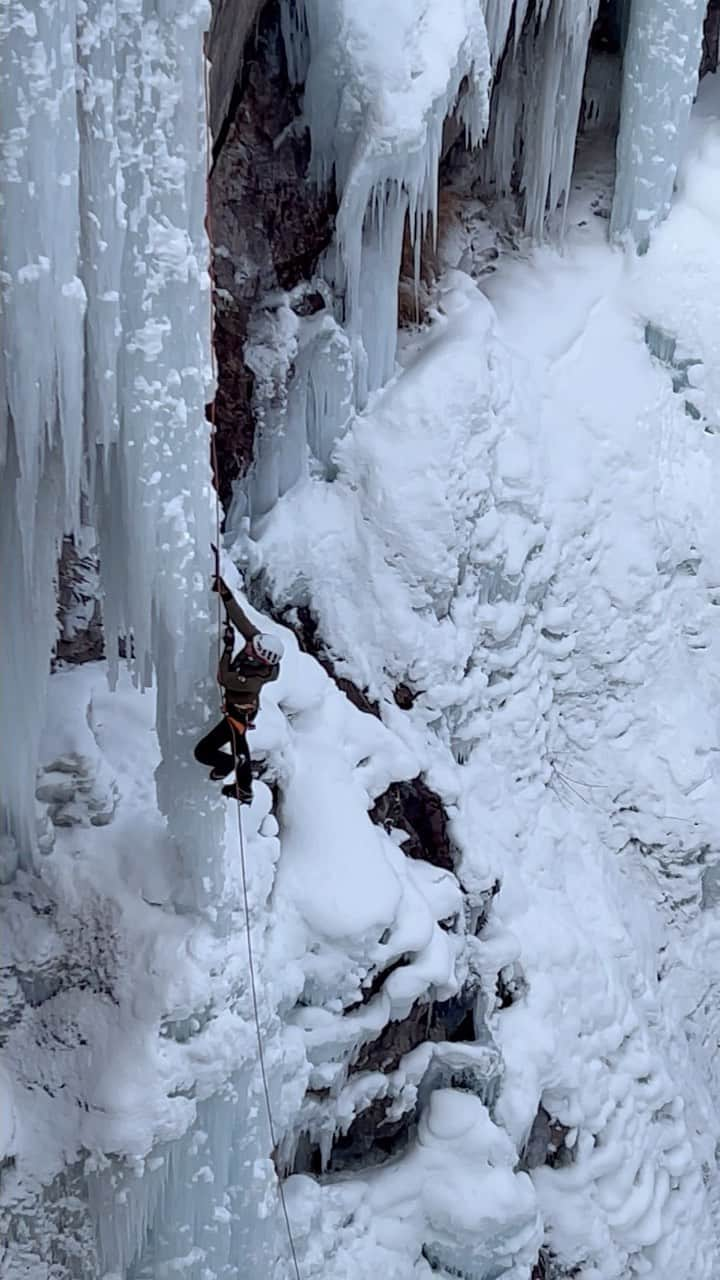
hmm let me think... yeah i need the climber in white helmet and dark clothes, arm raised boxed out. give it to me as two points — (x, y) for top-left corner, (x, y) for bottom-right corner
(195, 577), (283, 804)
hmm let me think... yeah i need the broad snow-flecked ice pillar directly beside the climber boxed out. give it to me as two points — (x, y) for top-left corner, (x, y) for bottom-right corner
(88, 0), (223, 908)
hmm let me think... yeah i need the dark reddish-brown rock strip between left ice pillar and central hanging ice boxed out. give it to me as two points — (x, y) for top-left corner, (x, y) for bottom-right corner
(208, 0), (334, 504)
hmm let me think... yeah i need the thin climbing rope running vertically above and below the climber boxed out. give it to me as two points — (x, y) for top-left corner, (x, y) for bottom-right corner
(202, 45), (301, 1280)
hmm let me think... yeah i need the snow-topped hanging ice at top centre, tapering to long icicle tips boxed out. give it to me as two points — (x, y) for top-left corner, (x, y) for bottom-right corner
(278, 0), (491, 406)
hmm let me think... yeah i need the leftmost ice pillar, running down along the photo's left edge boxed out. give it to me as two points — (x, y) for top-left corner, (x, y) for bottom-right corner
(0, 0), (85, 874)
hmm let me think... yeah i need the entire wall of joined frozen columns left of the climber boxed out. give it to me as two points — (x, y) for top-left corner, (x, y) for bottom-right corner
(0, 0), (220, 904)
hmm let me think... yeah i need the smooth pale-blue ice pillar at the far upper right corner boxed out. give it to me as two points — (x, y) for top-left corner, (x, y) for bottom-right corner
(610, 0), (706, 251)
